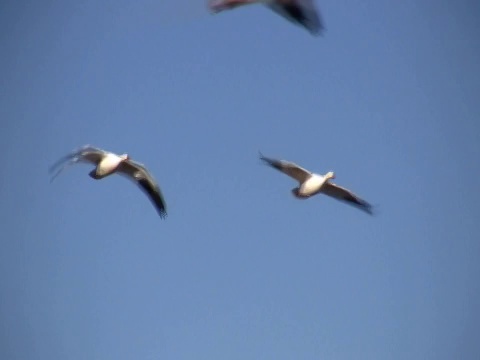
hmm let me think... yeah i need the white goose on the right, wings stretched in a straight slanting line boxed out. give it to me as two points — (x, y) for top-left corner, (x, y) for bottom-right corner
(260, 153), (373, 215)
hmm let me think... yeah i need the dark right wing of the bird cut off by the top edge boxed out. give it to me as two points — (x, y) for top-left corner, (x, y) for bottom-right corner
(266, 0), (325, 35)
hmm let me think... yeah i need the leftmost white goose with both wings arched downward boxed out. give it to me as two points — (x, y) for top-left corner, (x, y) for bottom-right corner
(49, 145), (167, 218)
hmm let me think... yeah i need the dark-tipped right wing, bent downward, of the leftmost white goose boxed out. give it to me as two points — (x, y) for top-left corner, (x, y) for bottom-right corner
(117, 160), (167, 219)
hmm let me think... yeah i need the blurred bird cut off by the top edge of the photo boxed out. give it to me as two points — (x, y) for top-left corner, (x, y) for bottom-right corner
(208, 0), (325, 35)
